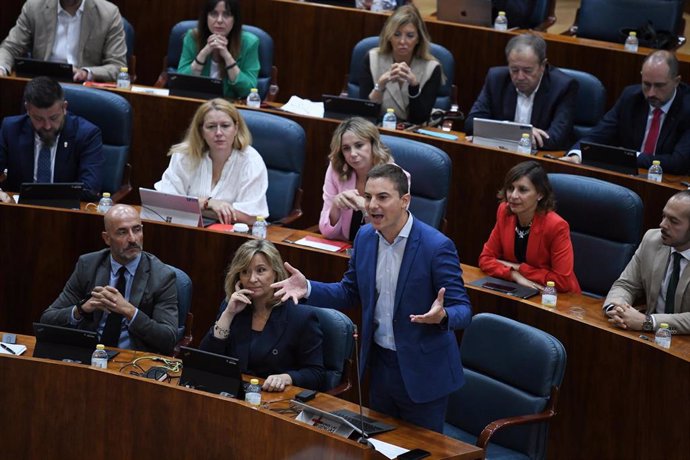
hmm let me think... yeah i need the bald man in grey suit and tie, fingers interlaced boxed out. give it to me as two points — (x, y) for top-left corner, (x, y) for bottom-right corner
(41, 204), (177, 355)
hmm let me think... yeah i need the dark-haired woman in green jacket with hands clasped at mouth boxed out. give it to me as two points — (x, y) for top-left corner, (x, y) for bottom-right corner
(177, 0), (259, 99)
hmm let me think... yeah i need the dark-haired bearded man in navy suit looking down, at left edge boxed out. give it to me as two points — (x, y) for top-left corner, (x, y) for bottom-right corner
(0, 77), (104, 202)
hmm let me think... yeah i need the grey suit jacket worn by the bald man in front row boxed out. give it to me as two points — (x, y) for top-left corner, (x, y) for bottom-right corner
(41, 248), (177, 355)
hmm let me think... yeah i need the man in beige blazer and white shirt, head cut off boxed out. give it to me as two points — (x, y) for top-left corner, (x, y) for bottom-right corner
(0, 0), (127, 81)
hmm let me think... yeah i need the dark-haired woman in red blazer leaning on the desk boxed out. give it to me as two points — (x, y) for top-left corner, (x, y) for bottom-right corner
(479, 161), (580, 293)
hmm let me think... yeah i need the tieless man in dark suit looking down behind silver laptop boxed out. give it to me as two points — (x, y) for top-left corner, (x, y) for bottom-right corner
(465, 34), (578, 150)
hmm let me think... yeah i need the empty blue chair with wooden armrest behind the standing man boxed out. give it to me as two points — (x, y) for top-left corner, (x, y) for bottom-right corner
(443, 313), (566, 459)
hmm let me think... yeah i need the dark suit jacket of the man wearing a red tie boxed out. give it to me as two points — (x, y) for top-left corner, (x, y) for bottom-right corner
(572, 83), (690, 174)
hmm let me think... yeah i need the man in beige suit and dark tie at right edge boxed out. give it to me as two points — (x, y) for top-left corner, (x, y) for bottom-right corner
(603, 190), (690, 334)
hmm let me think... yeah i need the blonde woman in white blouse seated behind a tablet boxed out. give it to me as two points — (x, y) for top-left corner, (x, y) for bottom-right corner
(154, 99), (268, 225)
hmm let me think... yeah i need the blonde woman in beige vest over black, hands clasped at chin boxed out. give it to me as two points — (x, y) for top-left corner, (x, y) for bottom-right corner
(359, 5), (443, 123)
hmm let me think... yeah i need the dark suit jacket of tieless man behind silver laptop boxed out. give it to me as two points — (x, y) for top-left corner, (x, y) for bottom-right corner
(465, 65), (579, 150)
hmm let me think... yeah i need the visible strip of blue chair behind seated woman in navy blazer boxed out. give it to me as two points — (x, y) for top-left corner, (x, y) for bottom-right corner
(298, 305), (355, 395)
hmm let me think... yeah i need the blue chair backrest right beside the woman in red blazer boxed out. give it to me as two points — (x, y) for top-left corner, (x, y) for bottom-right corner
(549, 174), (643, 296)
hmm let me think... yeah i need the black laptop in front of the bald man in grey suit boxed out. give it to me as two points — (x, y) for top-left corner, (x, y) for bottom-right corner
(34, 323), (119, 365)
